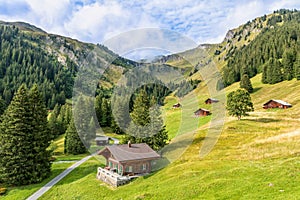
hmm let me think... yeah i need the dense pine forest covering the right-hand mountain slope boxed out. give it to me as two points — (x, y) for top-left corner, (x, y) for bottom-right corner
(222, 10), (300, 86)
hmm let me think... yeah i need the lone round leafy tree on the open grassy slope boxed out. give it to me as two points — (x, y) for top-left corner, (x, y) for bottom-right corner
(226, 89), (254, 120)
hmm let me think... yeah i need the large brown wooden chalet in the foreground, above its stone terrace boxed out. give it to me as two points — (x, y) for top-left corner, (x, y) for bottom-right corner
(98, 143), (160, 176)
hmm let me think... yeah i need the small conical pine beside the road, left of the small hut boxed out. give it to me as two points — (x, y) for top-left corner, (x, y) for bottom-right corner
(65, 119), (86, 155)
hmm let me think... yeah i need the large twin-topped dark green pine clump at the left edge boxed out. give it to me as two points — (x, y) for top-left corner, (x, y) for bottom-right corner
(0, 85), (51, 185)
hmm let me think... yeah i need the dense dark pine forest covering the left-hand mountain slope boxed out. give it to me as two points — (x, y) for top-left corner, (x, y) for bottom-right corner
(0, 26), (78, 108)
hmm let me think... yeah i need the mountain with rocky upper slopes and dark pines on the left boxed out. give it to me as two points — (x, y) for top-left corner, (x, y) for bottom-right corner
(0, 21), (135, 109)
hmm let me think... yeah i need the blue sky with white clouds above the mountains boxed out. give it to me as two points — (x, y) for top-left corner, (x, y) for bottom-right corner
(0, 0), (300, 59)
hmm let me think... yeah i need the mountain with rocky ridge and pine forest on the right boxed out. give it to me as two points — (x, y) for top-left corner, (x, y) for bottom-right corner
(158, 9), (300, 86)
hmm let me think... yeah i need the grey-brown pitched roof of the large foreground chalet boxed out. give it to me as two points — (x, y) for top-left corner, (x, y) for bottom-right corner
(98, 143), (160, 162)
